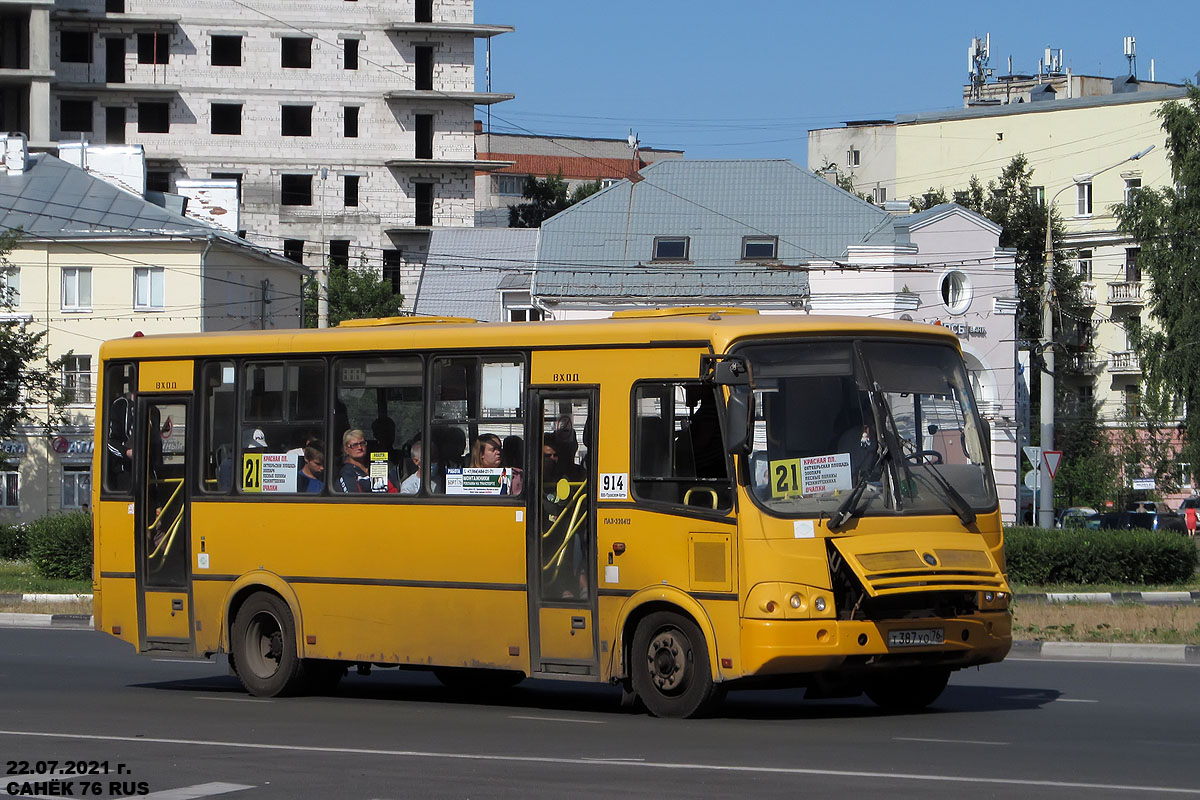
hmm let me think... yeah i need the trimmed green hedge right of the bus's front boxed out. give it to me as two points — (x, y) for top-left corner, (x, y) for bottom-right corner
(1004, 527), (1200, 585)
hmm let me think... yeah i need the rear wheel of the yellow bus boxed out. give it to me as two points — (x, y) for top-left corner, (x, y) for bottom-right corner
(230, 591), (305, 697)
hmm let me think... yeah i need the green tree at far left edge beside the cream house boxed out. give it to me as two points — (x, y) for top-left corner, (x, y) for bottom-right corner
(0, 230), (70, 455)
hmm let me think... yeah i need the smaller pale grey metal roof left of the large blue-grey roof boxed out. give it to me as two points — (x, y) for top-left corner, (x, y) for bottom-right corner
(413, 228), (538, 321)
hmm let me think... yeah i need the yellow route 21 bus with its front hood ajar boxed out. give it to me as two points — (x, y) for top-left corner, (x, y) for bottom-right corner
(92, 308), (1012, 716)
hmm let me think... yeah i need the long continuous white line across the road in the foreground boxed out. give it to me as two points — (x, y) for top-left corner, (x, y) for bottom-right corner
(0, 730), (1200, 798)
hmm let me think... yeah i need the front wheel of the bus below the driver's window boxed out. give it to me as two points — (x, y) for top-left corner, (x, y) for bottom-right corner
(630, 612), (724, 717)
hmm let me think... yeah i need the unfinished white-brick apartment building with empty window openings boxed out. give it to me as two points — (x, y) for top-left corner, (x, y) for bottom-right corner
(0, 0), (512, 305)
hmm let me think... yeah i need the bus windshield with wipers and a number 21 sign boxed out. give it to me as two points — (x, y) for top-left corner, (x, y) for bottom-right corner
(738, 341), (996, 520)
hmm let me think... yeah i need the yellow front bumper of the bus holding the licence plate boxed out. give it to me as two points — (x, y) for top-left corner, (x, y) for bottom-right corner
(740, 612), (1013, 676)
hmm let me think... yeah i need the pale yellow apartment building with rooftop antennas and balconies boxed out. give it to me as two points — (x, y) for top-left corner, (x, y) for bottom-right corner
(809, 86), (1190, 483)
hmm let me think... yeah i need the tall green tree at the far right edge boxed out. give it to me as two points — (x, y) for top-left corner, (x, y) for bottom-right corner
(1112, 85), (1200, 467)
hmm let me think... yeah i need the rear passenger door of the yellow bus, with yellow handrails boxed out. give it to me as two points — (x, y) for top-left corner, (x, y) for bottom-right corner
(133, 395), (192, 652)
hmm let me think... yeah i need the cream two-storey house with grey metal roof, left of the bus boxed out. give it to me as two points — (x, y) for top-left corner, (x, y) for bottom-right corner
(0, 136), (305, 523)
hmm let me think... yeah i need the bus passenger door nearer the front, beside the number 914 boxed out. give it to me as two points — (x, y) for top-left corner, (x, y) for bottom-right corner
(527, 389), (600, 675)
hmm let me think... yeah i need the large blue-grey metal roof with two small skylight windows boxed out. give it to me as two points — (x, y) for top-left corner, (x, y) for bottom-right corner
(533, 160), (907, 302)
